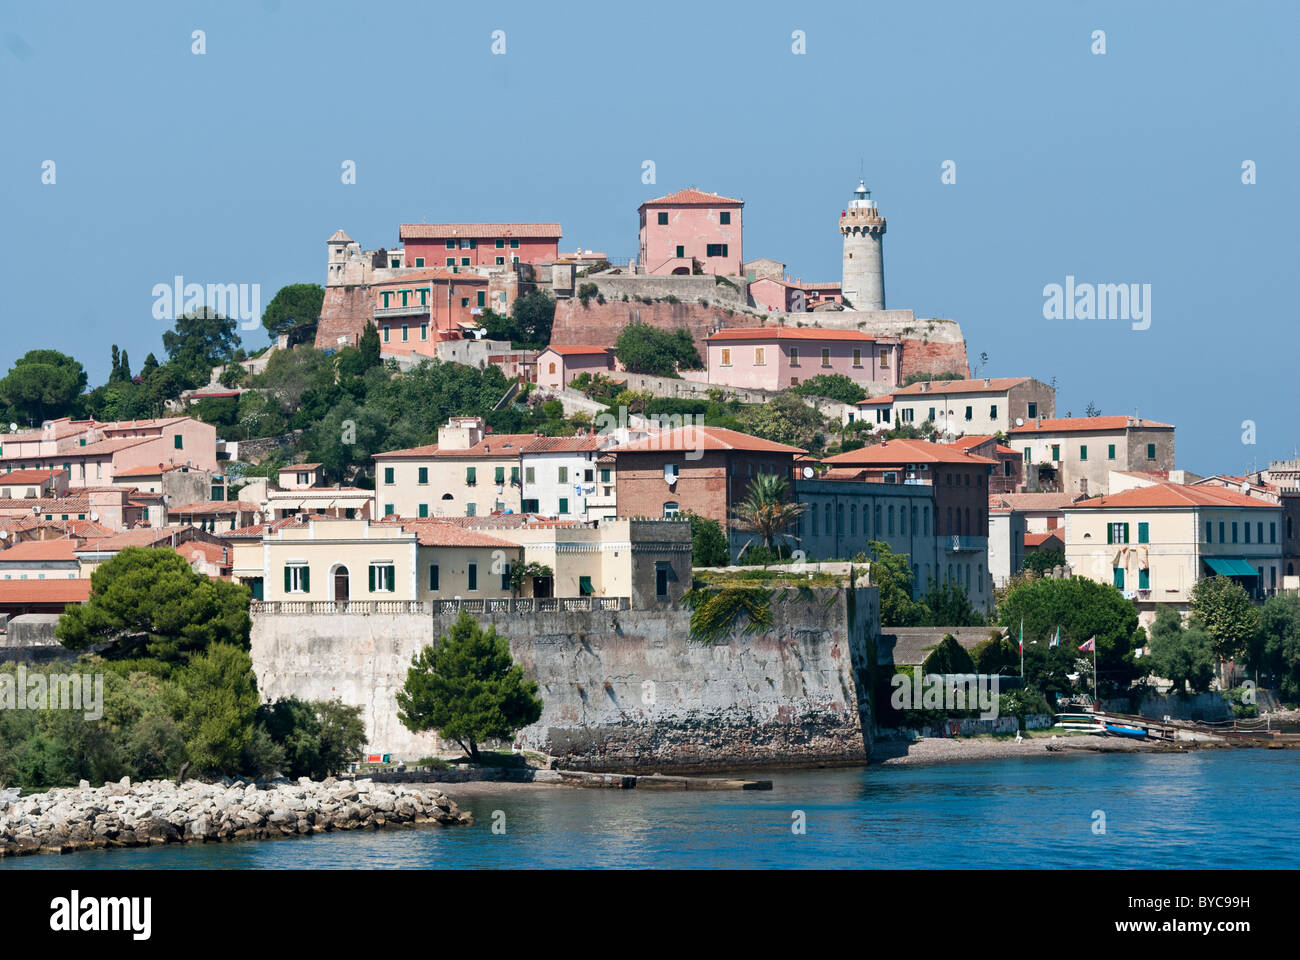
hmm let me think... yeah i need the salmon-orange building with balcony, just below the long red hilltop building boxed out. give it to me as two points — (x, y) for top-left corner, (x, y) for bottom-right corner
(371, 267), (488, 356)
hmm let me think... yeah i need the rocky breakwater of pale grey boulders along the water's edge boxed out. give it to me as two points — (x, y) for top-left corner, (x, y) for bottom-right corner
(0, 777), (473, 857)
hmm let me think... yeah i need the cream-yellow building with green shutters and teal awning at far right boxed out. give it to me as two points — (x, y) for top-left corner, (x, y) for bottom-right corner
(1062, 483), (1283, 623)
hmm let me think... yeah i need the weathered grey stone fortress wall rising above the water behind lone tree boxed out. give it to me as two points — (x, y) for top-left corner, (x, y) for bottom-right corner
(252, 587), (879, 770)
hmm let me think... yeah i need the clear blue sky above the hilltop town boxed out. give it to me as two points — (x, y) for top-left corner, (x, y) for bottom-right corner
(0, 0), (1300, 472)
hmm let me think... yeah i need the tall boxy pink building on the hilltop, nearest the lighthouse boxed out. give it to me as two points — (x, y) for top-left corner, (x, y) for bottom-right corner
(637, 189), (745, 277)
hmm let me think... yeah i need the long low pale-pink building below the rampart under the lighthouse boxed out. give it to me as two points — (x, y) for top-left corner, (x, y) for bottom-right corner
(705, 327), (898, 390)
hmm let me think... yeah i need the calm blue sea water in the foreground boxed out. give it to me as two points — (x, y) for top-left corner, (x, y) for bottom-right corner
(0, 751), (1300, 870)
